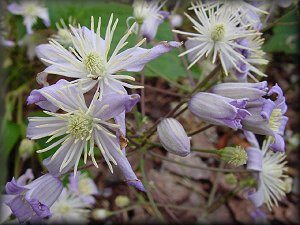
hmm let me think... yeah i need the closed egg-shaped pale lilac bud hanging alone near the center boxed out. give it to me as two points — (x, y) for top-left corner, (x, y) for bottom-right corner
(157, 118), (190, 157)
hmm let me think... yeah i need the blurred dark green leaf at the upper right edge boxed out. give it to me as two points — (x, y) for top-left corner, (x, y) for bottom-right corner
(263, 10), (300, 54)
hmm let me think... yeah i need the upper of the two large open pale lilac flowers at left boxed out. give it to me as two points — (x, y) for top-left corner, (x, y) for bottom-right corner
(38, 15), (181, 98)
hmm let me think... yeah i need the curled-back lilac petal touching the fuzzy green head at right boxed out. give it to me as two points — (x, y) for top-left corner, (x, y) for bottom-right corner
(246, 147), (263, 171)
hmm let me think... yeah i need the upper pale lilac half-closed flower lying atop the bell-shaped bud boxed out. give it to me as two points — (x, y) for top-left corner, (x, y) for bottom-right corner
(212, 81), (268, 100)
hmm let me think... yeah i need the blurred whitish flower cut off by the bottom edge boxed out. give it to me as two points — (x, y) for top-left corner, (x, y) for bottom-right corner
(47, 188), (92, 224)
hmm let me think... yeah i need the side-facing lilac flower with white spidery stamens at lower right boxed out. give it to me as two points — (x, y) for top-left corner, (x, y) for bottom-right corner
(245, 132), (288, 210)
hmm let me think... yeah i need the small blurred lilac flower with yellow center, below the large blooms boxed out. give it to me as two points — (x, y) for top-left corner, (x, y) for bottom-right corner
(69, 171), (99, 204)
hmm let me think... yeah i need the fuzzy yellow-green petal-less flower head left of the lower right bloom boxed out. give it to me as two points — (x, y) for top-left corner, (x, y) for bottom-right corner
(219, 146), (248, 167)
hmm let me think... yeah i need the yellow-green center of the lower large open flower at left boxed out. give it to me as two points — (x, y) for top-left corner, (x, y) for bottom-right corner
(68, 112), (93, 140)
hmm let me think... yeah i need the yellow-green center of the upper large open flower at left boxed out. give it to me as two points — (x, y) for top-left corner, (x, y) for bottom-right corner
(83, 52), (106, 79)
